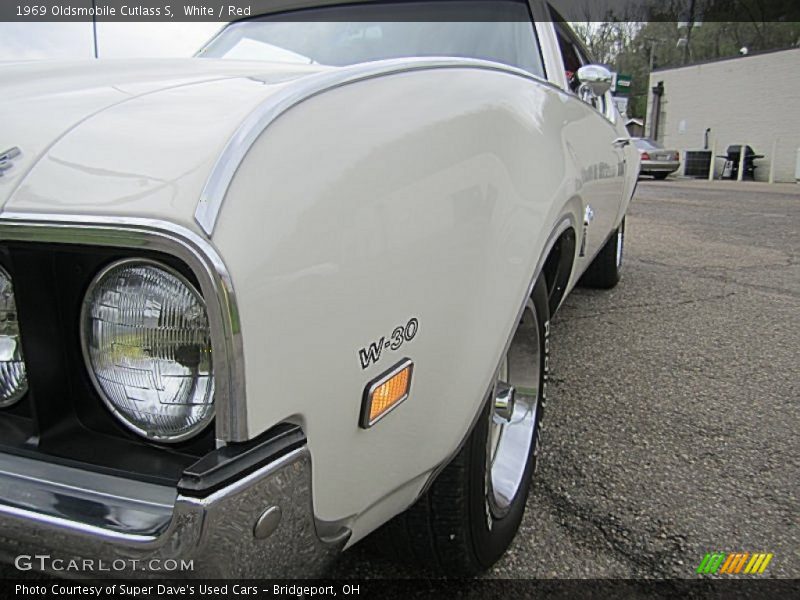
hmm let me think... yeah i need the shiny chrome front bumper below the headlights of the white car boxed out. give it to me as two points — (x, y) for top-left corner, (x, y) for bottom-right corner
(0, 446), (347, 579)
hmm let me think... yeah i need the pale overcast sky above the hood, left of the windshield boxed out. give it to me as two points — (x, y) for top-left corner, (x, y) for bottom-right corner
(0, 22), (224, 60)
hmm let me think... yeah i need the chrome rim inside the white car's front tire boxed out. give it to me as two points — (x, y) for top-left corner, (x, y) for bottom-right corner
(486, 306), (541, 519)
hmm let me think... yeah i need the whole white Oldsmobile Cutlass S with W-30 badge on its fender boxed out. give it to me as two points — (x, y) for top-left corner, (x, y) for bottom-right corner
(0, 0), (638, 577)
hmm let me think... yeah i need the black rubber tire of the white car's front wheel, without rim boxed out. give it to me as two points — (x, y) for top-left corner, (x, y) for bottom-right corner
(374, 281), (550, 576)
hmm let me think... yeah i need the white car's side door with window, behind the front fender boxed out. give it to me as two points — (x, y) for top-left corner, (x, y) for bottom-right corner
(542, 5), (629, 271)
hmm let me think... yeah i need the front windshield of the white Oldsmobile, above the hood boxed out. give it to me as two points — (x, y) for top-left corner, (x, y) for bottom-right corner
(198, 0), (544, 75)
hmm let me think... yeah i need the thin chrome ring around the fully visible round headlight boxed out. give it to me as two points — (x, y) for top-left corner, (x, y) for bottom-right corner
(78, 257), (217, 444)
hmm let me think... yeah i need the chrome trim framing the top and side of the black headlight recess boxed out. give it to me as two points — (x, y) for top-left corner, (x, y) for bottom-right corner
(0, 211), (248, 443)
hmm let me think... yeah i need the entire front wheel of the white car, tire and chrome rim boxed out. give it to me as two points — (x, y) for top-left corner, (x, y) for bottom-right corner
(378, 281), (549, 576)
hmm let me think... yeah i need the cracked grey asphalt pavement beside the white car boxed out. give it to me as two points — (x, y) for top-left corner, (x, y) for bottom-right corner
(334, 180), (800, 578)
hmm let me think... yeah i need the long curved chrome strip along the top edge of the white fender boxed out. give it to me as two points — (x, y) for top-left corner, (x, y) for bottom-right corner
(194, 57), (563, 237)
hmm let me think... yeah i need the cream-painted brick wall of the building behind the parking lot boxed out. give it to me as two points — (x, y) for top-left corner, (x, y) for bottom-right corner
(645, 48), (800, 181)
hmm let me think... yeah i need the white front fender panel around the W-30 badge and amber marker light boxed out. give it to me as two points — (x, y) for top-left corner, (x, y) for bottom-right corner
(213, 65), (596, 541)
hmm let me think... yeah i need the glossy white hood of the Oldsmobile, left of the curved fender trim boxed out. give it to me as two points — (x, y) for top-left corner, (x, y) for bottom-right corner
(0, 59), (320, 228)
